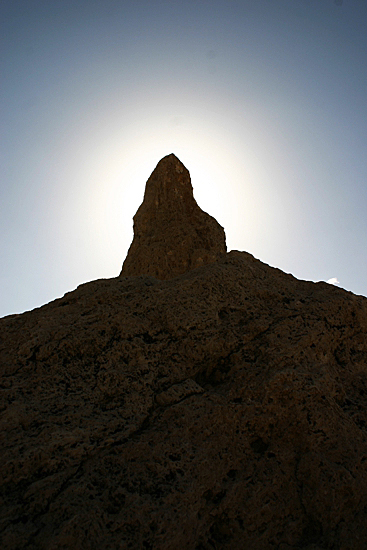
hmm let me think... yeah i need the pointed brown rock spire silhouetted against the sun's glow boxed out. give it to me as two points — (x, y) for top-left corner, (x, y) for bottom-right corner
(121, 155), (226, 279)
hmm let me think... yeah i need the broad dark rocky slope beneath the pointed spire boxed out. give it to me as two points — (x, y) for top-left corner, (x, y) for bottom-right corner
(0, 252), (367, 550)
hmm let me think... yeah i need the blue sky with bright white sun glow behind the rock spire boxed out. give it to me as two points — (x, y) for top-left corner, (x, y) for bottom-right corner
(0, 0), (367, 316)
